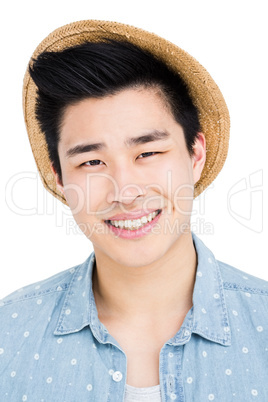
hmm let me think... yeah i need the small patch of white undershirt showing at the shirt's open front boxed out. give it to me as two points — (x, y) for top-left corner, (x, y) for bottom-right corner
(124, 385), (161, 402)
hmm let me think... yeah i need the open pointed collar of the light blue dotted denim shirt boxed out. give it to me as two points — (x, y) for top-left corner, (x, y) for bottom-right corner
(54, 234), (231, 346)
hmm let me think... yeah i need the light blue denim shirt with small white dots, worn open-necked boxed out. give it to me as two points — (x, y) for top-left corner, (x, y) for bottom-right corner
(0, 235), (268, 402)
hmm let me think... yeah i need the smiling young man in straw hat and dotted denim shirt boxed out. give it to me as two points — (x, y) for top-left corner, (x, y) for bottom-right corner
(0, 21), (268, 402)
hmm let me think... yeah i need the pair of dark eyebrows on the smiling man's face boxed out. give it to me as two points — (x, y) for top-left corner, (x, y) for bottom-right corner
(66, 130), (170, 158)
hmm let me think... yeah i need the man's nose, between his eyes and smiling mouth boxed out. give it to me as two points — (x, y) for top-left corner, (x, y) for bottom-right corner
(107, 167), (146, 205)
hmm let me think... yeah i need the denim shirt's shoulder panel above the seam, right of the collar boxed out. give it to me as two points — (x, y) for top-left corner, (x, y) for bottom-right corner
(217, 261), (268, 297)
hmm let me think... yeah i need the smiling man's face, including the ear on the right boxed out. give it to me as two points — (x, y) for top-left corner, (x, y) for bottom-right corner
(54, 88), (205, 267)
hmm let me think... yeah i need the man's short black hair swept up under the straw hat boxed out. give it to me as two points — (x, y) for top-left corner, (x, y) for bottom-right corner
(29, 40), (200, 180)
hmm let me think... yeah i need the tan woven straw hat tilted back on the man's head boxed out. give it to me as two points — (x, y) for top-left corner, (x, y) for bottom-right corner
(23, 20), (230, 204)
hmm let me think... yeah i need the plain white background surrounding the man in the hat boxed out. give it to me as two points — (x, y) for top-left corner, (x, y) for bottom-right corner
(0, 0), (268, 298)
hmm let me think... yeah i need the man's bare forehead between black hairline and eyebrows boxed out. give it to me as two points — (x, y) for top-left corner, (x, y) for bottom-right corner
(60, 88), (180, 146)
